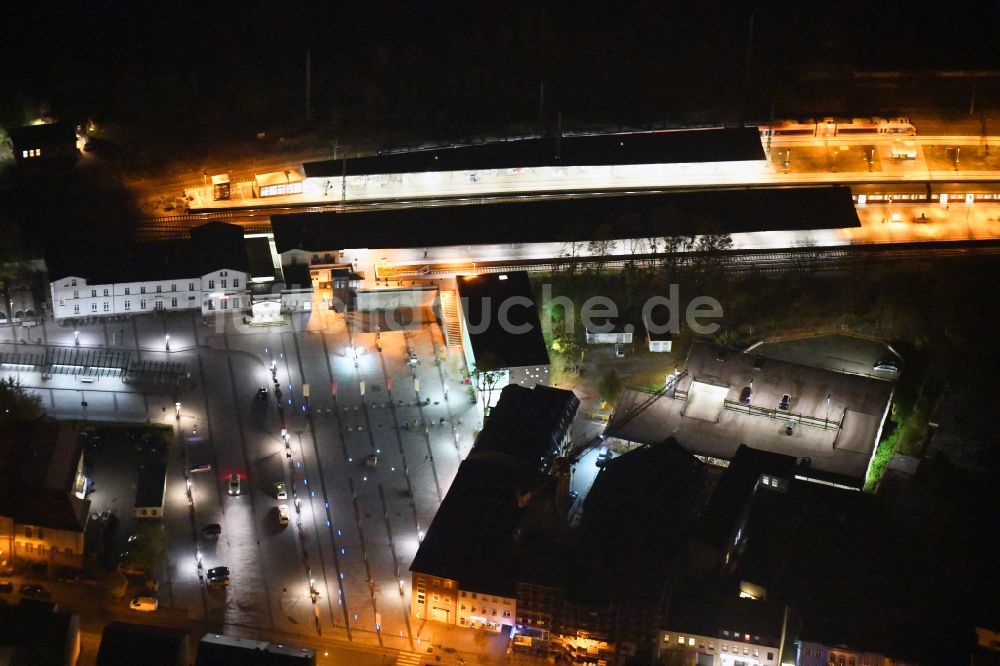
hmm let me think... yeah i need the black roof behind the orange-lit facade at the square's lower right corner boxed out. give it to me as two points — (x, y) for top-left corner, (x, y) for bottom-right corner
(410, 452), (547, 597)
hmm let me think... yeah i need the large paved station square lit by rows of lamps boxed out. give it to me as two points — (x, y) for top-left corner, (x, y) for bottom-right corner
(0, 310), (481, 651)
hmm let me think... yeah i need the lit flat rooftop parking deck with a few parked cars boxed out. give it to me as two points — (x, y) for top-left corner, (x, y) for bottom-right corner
(608, 342), (893, 479)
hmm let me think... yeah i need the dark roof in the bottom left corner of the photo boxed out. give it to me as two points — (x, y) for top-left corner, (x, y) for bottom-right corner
(0, 604), (80, 665)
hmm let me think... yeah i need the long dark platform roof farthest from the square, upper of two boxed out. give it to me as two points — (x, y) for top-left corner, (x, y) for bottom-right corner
(304, 127), (766, 178)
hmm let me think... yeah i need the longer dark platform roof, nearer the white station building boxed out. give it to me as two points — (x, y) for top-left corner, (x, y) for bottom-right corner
(271, 186), (860, 252)
